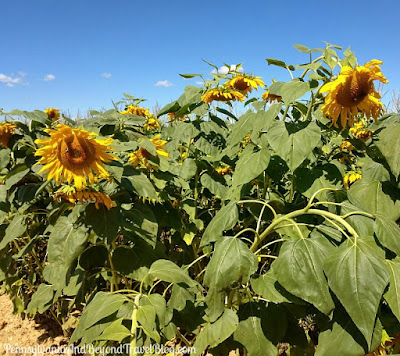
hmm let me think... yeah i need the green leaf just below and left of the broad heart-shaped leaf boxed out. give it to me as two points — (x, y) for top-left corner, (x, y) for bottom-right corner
(232, 148), (270, 186)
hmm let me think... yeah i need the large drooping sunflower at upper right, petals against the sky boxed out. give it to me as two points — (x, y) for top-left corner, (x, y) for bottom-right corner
(321, 59), (388, 128)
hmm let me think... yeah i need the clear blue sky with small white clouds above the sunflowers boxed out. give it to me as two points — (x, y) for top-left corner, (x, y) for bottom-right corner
(0, 0), (400, 116)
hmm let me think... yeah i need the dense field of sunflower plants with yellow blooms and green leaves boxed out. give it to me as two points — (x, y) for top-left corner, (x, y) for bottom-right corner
(0, 44), (400, 356)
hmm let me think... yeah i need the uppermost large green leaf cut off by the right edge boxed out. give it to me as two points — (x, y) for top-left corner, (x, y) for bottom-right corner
(375, 124), (400, 178)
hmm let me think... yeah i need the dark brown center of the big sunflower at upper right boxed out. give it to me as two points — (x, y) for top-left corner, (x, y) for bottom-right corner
(336, 72), (373, 107)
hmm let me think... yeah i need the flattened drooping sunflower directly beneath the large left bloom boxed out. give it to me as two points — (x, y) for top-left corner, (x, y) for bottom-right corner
(54, 186), (117, 210)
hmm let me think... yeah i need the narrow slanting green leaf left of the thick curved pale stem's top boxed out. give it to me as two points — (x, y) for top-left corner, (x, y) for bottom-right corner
(200, 201), (239, 247)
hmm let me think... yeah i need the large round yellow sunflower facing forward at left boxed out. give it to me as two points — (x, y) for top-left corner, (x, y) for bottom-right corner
(35, 125), (116, 190)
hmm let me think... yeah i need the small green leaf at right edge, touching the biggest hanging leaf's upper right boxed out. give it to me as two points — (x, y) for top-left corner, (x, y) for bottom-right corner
(374, 214), (400, 256)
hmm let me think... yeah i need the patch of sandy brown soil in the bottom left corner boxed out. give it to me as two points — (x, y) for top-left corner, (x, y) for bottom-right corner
(0, 294), (68, 355)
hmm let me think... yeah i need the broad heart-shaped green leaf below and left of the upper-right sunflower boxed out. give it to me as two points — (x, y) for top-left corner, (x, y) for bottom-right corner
(267, 121), (321, 172)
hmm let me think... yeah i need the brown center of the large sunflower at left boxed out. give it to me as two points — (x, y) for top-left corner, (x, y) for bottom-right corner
(59, 135), (96, 168)
